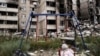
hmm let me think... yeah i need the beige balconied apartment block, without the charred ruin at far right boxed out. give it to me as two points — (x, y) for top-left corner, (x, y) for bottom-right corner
(0, 0), (77, 35)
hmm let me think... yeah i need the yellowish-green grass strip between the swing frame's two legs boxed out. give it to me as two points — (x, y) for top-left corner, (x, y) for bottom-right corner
(30, 39), (61, 50)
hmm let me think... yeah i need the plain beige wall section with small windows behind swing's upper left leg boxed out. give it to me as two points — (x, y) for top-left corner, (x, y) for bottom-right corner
(19, 0), (37, 32)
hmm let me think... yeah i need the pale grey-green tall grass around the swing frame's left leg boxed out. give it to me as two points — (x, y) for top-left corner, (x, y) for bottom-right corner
(0, 40), (30, 56)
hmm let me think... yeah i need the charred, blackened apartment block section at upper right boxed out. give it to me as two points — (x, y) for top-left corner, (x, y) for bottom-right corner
(77, 0), (100, 24)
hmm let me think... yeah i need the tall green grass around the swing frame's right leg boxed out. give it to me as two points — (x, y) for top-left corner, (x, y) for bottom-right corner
(77, 36), (100, 56)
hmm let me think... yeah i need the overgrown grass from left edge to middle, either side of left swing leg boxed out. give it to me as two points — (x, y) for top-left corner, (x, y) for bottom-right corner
(0, 37), (61, 56)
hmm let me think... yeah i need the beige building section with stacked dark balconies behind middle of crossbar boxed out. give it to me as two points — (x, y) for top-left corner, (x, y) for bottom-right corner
(38, 0), (59, 35)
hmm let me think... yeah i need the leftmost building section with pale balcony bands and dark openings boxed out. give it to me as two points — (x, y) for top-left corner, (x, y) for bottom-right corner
(0, 0), (18, 34)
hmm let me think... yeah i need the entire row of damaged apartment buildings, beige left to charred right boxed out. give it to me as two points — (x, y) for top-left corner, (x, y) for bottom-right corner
(0, 0), (100, 35)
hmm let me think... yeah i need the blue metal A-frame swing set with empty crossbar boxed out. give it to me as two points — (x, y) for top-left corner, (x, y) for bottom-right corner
(15, 11), (86, 56)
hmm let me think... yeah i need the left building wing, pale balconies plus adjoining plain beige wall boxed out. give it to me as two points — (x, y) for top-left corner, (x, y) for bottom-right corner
(0, 0), (37, 34)
